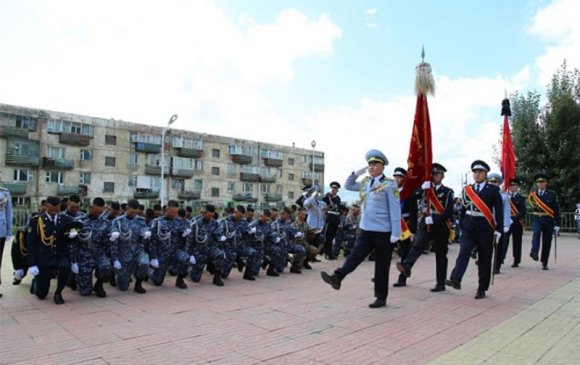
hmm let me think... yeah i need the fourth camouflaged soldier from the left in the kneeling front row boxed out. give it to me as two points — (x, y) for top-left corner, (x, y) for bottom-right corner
(187, 204), (227, 286)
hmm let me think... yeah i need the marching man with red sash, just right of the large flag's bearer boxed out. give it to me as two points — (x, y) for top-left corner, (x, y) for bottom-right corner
(445, 160), (503, 299)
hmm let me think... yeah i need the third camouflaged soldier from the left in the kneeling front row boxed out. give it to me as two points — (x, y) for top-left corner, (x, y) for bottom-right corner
(149, 200), (195, 289)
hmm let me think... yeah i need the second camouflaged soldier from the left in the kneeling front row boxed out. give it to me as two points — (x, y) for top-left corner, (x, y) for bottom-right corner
(111, 199), (151, 294)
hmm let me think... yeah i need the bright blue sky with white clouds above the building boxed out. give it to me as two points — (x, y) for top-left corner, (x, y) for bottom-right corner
(0, 0), (580, 200)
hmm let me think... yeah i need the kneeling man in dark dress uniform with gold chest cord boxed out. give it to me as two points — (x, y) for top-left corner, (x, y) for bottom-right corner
(26, 196), (78, 304)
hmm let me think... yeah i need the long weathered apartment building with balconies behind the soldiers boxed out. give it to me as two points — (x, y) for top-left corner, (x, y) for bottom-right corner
(0, 104), (324, 207)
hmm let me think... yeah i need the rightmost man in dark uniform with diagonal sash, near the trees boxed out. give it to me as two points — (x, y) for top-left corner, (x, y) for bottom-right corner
(528, 174), (560, 270)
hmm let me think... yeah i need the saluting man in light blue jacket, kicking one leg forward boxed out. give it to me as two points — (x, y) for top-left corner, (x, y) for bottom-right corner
(321, 150), (401, 308)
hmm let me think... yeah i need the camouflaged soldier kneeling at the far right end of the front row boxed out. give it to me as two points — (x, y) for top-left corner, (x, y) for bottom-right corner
(272, 208), (306, 274)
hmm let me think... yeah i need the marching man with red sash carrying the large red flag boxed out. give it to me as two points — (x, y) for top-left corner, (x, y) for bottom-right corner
(397, 163), (453, 292)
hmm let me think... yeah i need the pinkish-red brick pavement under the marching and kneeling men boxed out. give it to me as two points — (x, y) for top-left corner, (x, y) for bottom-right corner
(0, 235), (580, 365)
